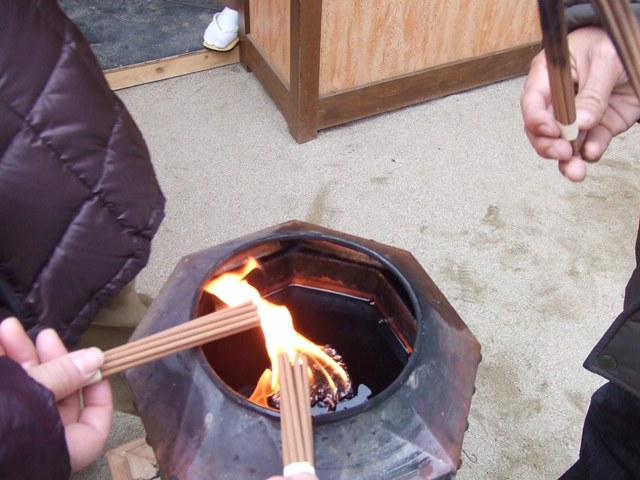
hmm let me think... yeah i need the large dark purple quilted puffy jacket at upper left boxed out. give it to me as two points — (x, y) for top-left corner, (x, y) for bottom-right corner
(0, 0), (164, 346)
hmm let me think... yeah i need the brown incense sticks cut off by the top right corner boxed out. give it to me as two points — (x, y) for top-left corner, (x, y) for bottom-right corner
(591, 0), (640, 97)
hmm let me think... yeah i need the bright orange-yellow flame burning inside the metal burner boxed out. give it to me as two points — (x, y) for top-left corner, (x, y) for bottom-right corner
(205, 258), (352, 406)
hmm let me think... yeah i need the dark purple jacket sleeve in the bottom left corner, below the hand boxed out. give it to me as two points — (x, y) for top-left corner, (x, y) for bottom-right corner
(0, 356), (71, 480)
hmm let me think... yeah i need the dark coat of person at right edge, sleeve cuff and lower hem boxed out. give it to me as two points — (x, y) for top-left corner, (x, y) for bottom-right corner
(565, 0), (640, 396)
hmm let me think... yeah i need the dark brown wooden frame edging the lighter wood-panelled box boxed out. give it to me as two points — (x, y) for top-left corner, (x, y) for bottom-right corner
(239, 0), (541, 143)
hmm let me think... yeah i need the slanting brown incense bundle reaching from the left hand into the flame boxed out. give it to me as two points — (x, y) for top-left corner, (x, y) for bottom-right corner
(100, 302), (260, 378)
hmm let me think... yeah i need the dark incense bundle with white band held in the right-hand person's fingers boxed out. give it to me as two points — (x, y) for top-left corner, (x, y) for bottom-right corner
(538, 0), (580, 153)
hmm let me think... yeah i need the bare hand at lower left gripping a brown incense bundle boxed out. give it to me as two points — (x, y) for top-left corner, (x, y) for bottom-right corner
(0, 318), (113, 470)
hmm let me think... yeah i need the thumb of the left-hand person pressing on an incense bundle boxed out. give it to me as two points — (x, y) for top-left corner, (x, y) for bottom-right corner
(28, 347), (104, 401)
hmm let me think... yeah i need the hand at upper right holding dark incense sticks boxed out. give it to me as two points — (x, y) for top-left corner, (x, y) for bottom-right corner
(520, 27), (640, 182)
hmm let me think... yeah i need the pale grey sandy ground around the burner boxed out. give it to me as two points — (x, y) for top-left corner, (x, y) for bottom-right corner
(71, 65), (640, 480)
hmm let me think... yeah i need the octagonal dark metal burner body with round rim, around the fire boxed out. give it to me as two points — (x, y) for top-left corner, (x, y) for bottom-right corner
(125, 221), (480, 480)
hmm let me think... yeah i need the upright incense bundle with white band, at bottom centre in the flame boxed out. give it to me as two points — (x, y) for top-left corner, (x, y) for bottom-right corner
(278, 353), (315, 476)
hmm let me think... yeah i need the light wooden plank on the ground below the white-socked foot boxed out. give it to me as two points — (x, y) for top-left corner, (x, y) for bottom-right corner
(104, 48), (240, 90)
